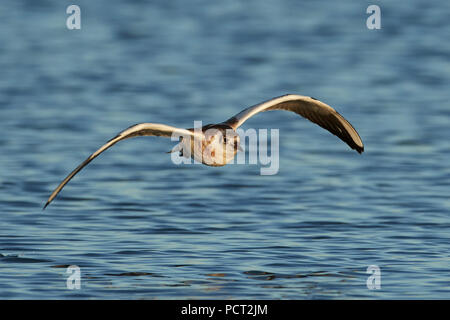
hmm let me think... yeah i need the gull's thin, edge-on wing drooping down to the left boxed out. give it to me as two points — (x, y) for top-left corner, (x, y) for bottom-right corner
(44, 123), (199, 209)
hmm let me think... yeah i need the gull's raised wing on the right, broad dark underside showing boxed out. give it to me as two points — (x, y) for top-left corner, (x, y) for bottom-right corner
(224, 94), (364, 153)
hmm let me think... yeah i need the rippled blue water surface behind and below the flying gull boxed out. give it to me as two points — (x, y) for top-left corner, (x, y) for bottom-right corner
(0, 0), (450, 299)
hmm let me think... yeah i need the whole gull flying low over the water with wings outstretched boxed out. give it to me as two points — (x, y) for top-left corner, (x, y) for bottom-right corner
(43, 94), (364, 209)
